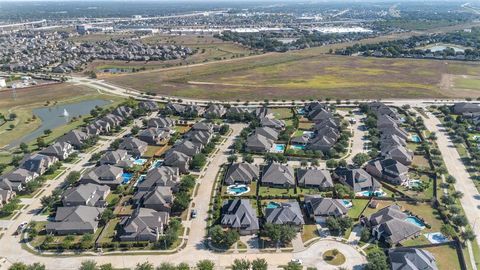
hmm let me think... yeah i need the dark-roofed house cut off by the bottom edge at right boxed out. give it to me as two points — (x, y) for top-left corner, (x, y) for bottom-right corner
(388, 248), (438, 270)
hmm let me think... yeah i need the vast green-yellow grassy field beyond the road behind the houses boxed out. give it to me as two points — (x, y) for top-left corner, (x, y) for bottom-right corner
(107, 42), (480, 100)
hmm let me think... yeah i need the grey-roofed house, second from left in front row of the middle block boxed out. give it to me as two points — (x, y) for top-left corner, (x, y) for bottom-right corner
(265, 201), (305, 228)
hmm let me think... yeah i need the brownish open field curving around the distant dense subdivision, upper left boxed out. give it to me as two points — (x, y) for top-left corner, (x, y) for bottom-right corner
(87, 35), (258, 77)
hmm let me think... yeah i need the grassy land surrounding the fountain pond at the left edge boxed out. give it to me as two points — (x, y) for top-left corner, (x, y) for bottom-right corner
(0, 83), (125, 147)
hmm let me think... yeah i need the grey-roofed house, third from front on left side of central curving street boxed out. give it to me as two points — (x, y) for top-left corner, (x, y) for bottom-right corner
(137, 166), (180, 191)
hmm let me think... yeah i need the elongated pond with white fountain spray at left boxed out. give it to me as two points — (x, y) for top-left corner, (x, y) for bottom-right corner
(9, 99), (110, 148)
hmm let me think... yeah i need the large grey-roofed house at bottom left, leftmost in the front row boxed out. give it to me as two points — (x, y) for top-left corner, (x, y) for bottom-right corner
(45, 205), (104, 235)
